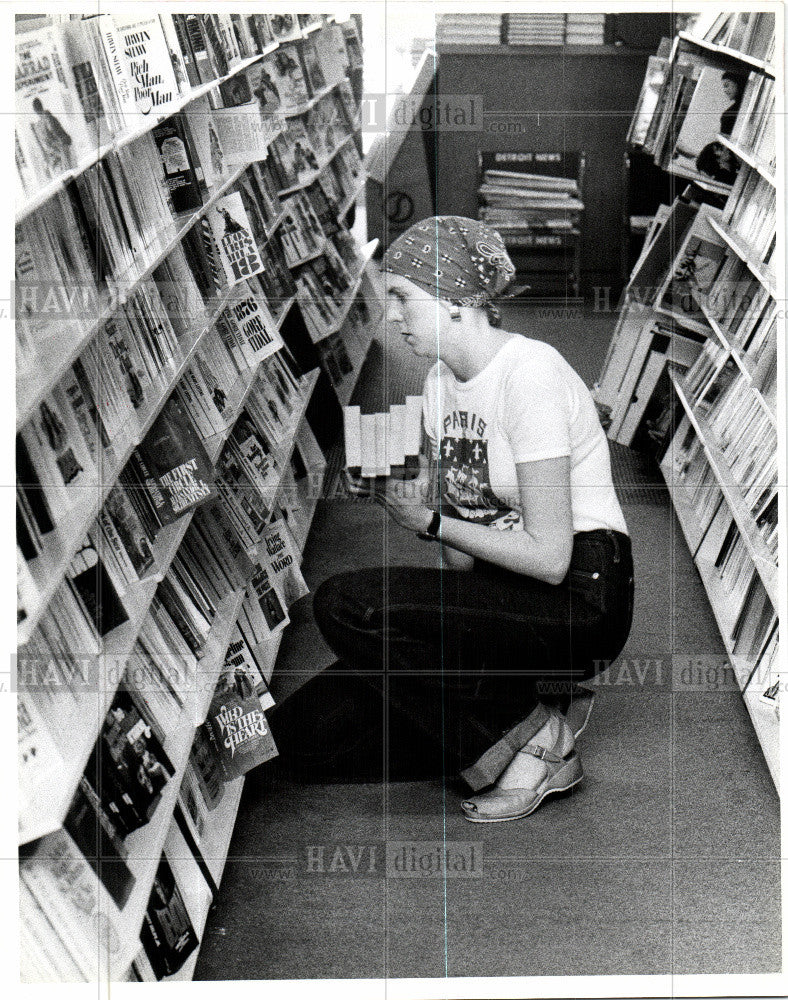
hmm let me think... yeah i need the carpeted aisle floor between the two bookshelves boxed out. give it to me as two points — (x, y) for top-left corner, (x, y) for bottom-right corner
(196, 305), (781, 980)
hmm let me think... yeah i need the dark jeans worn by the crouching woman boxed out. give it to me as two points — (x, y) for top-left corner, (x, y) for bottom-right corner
(271, 530), (633, 781)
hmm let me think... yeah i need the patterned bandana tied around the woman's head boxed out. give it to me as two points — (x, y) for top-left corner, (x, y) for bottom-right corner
(383, 215), (514, 306)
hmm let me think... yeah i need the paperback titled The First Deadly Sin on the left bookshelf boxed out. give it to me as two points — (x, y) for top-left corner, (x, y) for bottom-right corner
(138, 397), (217, 524)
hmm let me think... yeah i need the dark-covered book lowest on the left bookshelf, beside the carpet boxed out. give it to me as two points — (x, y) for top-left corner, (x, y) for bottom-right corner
(140, 853), (200, 980)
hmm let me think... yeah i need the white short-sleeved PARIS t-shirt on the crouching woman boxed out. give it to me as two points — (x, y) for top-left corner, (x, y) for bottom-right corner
(424, 336), (627, 533)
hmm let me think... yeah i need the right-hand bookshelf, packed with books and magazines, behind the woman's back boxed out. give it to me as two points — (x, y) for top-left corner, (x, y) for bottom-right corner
(595, 12), (785, 791)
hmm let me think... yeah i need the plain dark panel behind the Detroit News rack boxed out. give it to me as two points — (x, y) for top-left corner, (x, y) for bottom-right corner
(436, 47), (648, 290)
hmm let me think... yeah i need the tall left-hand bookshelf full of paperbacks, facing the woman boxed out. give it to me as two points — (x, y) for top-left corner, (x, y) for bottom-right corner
(16, 8), (380, 982)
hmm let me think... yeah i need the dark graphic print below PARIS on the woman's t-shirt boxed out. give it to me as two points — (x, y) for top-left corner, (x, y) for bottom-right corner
(438, 424), (520, 528)
